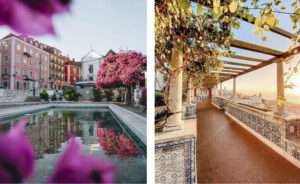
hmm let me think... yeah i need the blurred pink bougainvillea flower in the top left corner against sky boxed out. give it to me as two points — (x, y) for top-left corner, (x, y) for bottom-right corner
(0, 0), (71, 35)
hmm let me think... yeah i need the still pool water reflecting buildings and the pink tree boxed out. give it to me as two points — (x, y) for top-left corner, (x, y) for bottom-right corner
(0, 108), (146, 183)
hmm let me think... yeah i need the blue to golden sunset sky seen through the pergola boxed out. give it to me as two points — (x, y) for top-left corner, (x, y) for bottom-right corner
(217, 0), (300, 103)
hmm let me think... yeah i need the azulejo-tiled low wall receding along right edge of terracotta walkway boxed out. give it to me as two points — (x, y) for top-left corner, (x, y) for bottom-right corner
(226, 103), (300, 160)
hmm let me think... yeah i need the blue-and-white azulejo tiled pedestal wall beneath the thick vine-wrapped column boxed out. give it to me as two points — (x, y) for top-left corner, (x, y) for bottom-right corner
(155, 137), (196, 184)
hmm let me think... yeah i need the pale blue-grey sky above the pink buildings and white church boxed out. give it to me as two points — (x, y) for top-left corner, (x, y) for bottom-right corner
(0, 0), (147, 61)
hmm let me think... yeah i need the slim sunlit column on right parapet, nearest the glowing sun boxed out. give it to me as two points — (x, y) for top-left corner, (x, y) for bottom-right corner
(276, 62), (285, 115)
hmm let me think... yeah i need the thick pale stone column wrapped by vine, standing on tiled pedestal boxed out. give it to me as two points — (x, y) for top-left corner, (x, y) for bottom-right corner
(163, 48), (183, 131)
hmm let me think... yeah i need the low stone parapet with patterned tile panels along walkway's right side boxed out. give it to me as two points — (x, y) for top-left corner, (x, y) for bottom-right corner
(226, 102), (300, 167)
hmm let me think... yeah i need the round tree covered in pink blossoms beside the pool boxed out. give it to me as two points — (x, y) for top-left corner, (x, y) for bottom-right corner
(96, 51), (147, 104)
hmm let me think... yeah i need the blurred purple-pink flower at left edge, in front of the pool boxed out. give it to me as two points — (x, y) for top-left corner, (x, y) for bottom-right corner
(0, 119), (34, 183)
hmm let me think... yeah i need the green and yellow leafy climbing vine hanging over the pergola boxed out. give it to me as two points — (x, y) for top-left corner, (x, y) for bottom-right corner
(155, 0), (300, 123)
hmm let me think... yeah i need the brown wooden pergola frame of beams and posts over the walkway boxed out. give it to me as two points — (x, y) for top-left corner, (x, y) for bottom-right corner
(191, 0), (300, 114)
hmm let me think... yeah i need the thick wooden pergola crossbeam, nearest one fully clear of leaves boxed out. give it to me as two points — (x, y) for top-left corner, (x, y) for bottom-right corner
(231, 40), (283, 56)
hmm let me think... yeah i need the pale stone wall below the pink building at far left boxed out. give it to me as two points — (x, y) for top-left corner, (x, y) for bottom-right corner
(0, 89), (40, 103)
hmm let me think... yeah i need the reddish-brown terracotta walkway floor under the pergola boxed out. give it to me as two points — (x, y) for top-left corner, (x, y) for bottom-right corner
(197, 101), (300, 183)
